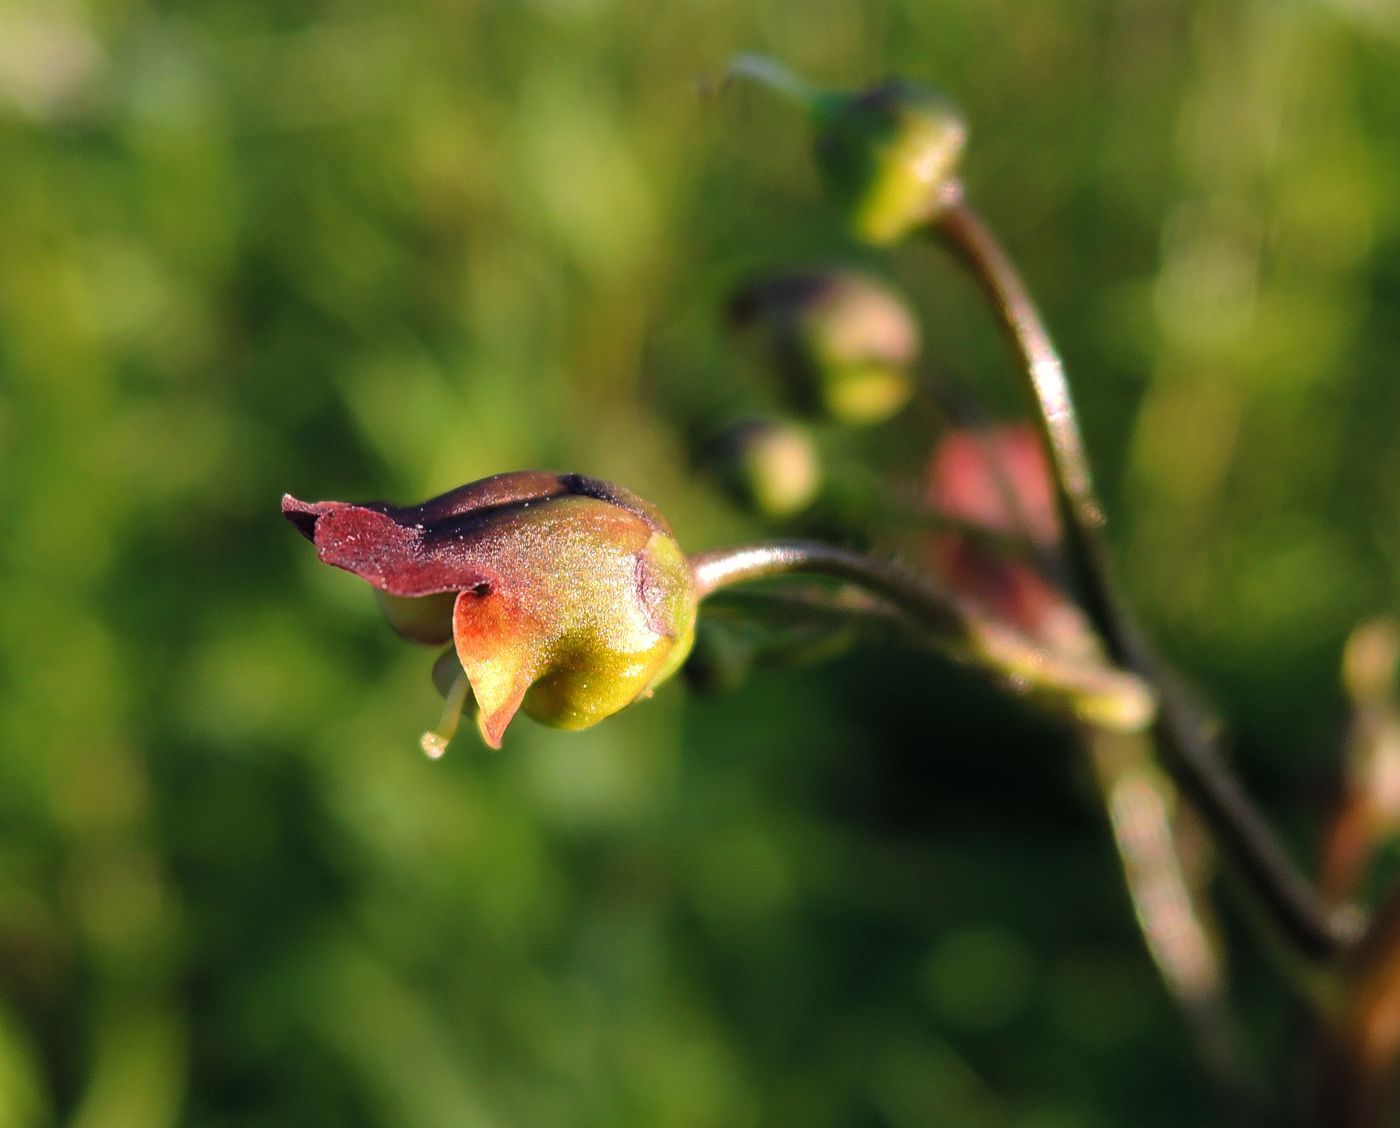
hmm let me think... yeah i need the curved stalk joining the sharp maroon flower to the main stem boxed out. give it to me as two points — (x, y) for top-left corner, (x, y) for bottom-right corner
(690, 540), (1156, 732)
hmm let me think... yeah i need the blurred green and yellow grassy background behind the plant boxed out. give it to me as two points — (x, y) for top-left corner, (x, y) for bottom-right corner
(0, 0), (1400, 1128)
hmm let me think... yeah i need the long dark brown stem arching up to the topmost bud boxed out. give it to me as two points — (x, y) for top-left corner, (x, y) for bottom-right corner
(934, 185), (1355, 960)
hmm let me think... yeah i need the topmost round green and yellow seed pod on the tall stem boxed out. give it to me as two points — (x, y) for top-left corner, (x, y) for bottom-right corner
(812, 80), (967, 246)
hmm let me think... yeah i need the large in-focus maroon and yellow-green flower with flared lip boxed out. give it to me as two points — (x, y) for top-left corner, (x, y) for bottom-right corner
(281, 470), (696, 747)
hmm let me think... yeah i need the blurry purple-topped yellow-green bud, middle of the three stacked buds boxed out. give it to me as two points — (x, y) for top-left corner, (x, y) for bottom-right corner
(729, 270), (920, 424)
